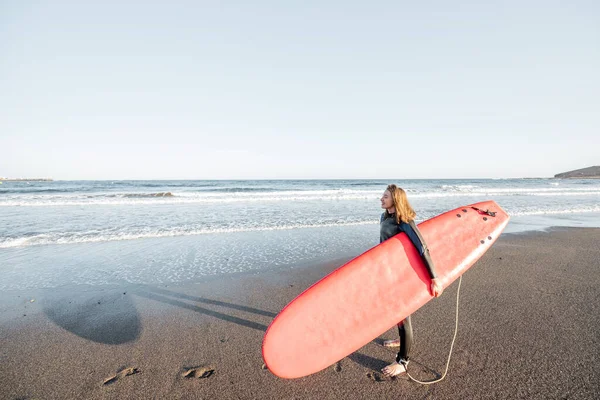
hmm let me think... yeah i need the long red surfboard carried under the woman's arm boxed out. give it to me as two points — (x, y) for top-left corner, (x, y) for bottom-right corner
(262, 201), (509, 379)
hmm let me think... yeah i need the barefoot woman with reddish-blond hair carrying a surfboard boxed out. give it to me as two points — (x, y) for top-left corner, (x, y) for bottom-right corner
(379, 185), (443, 377)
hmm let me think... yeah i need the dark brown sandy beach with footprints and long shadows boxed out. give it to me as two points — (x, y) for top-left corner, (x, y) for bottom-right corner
(0, 228), (600, 399)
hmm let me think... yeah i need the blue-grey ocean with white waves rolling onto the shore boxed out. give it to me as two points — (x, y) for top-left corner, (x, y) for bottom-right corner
(0, 179), (600, 290)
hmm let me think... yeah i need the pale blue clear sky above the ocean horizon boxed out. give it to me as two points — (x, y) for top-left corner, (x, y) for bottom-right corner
(0, 0), (600, 180)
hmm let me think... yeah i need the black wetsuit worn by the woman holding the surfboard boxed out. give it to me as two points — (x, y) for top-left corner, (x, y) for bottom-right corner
(379, 212), (436, 362)
